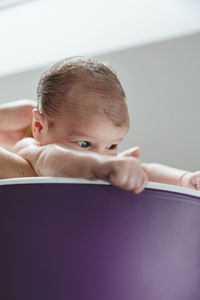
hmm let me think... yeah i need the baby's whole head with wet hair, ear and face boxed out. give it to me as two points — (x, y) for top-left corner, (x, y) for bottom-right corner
(32, 57), (129, 155)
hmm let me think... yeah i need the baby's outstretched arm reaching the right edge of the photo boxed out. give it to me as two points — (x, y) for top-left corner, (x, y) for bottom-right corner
(142, 163), (200, 190)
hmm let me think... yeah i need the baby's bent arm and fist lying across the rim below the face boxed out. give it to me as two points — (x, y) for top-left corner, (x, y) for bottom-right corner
(13, 138), (147, 193)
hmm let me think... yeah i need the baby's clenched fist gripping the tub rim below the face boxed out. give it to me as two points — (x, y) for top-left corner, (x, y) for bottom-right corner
(95, 156), (148, 194)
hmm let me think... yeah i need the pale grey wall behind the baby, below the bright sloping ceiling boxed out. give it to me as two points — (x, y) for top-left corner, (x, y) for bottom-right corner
(0, 33), (200, 170)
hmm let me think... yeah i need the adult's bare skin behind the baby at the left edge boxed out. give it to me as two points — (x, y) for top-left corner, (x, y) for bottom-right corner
(0, 100), (36, 179)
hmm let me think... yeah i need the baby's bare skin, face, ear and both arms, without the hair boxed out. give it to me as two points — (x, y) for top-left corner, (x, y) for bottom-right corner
(15, 110), (200, 193)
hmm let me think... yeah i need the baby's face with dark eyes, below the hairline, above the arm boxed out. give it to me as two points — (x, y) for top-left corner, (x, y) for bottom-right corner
(40, 117), (128, 155)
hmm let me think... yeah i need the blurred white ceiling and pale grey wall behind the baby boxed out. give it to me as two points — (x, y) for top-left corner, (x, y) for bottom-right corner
(0, 0), (200, 171)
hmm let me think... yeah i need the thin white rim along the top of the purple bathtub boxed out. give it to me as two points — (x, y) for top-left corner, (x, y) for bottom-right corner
(0, 177), (200, 198)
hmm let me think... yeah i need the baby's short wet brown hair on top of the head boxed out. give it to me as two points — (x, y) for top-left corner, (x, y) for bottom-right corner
(37, 57), (129, 126)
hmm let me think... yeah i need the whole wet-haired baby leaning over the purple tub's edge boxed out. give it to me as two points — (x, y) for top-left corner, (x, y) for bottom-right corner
(13, 57), (200, 193)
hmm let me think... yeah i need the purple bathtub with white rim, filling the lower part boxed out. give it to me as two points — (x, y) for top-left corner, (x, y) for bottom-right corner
(0, 178), (200, 300)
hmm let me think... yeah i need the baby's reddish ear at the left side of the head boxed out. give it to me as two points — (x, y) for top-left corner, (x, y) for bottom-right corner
(32, 108), (47, 142)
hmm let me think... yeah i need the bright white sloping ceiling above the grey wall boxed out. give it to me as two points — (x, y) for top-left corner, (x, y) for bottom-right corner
(0, 0), (200, 76)
